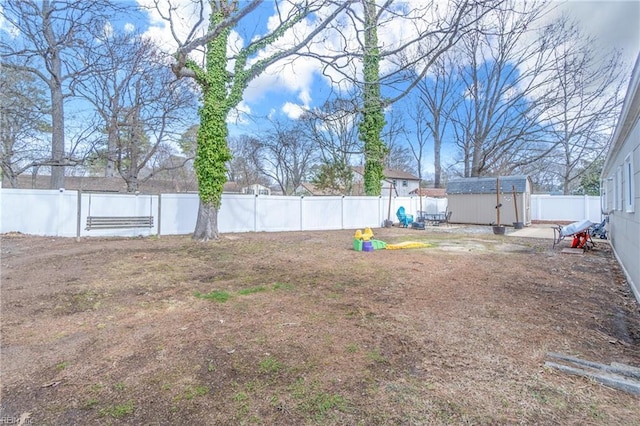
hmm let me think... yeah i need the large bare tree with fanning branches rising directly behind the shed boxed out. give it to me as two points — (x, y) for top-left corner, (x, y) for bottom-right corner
(452, 2), (560, 176)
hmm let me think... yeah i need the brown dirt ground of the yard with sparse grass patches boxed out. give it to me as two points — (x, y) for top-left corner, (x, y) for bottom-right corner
(0, 227), (640, 425)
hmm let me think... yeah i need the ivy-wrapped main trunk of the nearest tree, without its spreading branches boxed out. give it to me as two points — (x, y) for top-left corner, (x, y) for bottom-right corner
(192, 12), (231, 241)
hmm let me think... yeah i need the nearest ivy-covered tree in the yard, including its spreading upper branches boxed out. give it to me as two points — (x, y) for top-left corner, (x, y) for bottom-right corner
(162, 0), (356, 241)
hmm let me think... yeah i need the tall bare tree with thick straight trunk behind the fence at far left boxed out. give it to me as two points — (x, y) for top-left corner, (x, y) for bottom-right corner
(0, 0), (126, 188)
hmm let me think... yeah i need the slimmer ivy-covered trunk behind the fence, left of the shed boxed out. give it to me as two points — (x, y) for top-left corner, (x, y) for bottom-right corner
(360, 0), (388, 195)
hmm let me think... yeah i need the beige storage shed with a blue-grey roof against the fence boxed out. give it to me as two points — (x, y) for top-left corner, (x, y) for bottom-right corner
(447, 176), (532, 226)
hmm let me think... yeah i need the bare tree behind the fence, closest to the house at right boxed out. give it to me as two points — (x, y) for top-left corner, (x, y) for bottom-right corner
(538, 18), (624, 194)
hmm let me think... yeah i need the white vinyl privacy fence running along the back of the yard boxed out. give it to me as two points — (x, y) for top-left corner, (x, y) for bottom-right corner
(0, 188), (601, 237)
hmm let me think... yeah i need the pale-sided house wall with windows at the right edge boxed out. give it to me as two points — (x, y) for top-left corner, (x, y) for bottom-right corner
(601, 55), (640, 302)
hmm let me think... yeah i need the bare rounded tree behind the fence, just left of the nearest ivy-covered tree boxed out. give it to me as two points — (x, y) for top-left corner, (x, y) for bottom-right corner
(73, 33), (195, 192)
